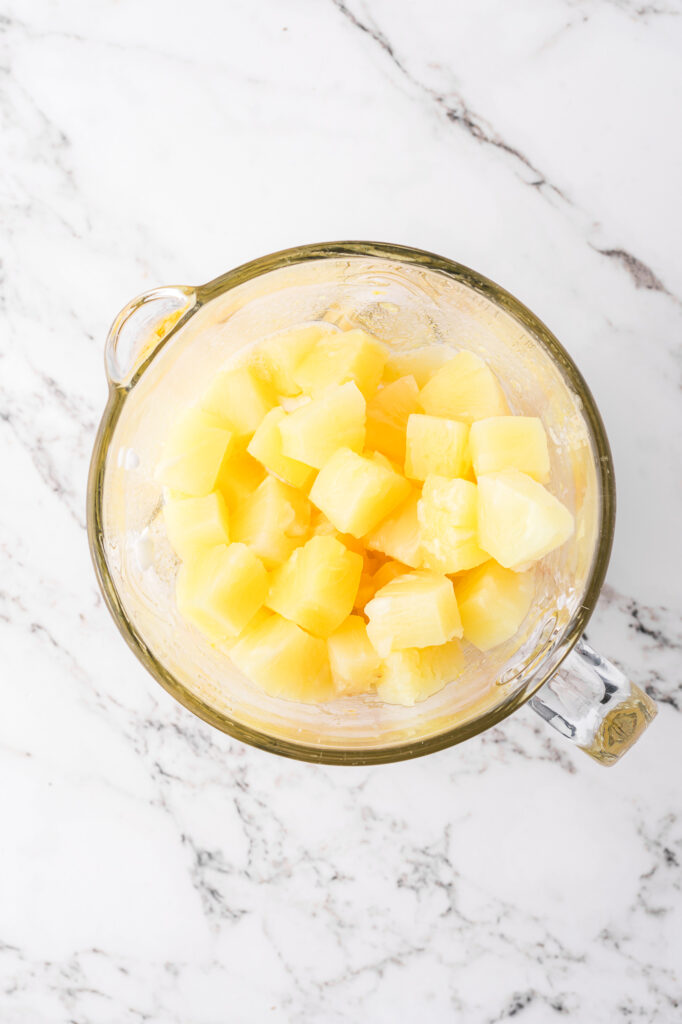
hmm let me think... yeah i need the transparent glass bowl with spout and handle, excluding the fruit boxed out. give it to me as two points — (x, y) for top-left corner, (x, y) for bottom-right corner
(88, 242), (655, 764)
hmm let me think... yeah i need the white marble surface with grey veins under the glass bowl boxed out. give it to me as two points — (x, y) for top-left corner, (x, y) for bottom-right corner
(0, 0), (682, 1024)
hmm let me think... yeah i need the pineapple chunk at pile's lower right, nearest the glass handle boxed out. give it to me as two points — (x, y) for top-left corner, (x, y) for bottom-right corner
(455, 559), (535, 650)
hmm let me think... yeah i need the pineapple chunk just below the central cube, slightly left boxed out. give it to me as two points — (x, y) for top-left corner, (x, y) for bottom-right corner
(267, 537), (363, 637)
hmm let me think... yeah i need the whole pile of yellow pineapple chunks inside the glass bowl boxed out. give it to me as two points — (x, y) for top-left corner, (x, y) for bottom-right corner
(157, 323), (573, 706)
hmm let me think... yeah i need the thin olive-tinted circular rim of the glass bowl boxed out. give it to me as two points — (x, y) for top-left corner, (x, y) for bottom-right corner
(86, 241), (615, 765)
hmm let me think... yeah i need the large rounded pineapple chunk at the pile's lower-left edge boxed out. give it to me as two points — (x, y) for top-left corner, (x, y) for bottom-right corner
(176, 544), (268, 642)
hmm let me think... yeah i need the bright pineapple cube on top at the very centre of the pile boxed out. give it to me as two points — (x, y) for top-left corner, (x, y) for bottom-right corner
(310, 447), (410, 537)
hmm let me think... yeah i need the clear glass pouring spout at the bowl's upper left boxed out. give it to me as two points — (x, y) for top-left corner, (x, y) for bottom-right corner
(104, 285), (197, 387)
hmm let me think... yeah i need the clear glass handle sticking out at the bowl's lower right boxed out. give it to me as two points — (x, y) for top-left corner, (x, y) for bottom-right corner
(529, 639), (657, 765)
